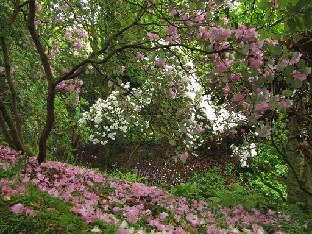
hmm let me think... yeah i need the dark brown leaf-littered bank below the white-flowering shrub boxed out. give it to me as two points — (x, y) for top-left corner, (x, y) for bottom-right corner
(76, 141), (240, 188)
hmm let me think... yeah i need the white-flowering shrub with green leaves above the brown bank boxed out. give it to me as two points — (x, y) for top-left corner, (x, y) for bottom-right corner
(79, 58), (213, 161)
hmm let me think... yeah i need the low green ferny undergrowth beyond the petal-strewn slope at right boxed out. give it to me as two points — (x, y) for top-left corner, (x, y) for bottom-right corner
(171, 161), (285, 211)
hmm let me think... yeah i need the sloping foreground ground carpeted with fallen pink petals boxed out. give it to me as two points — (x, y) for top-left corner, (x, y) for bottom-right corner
(0, 146), (308, 234)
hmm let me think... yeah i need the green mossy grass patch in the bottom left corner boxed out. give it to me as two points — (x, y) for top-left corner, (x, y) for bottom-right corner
(0, 186), (90, 234)
